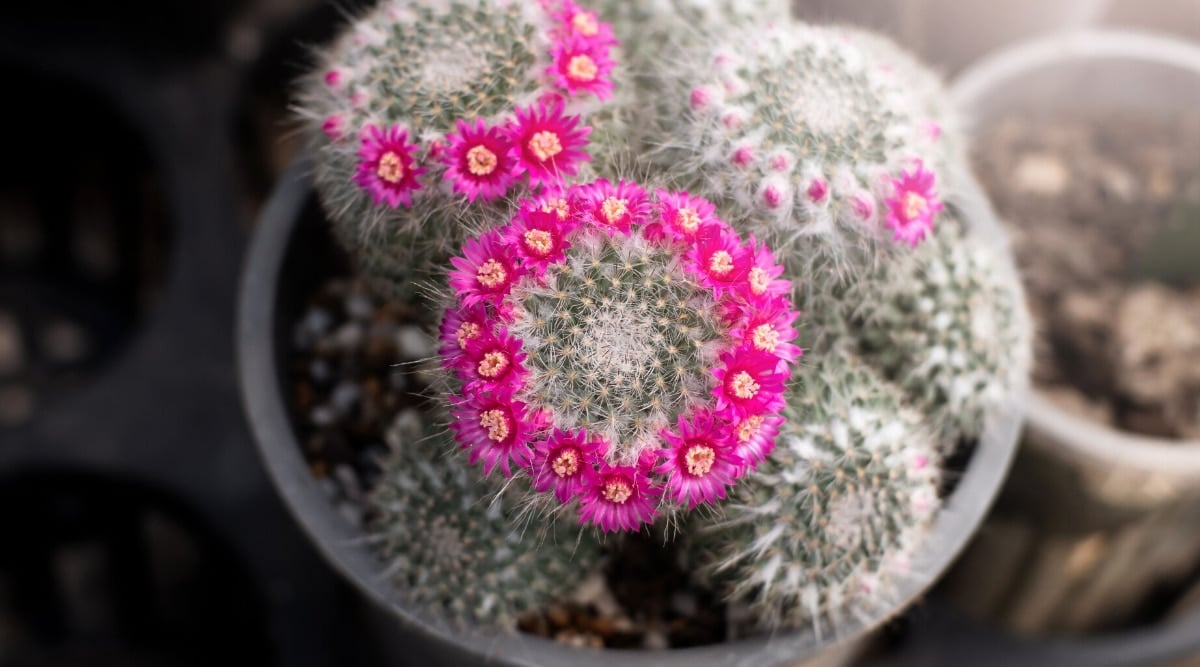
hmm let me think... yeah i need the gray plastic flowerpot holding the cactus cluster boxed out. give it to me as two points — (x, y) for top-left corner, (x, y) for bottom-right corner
(238, 157), (1022, 667)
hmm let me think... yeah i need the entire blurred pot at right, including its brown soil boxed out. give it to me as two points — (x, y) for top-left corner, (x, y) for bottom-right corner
(948, 31), (1200, 644)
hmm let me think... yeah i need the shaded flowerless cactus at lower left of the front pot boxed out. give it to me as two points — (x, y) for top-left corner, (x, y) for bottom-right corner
(371, 400), (602, 631)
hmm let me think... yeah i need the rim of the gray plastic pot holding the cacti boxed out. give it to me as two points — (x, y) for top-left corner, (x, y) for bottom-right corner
(236, 158), (1025, 667)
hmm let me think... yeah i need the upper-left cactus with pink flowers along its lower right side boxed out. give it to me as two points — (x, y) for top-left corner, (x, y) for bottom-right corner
(299, 0), (617, 298)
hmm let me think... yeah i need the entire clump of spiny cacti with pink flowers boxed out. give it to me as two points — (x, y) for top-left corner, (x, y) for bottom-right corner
(292, 0), (1030, 639)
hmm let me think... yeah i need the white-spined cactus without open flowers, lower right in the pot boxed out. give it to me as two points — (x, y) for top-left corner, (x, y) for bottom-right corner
(690, 354), (940, 636)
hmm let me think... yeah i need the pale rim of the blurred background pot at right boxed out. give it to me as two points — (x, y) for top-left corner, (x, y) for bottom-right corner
(950, 29), (1200, 477)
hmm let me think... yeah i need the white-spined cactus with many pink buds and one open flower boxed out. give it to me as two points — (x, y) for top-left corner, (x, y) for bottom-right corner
(640, 24), (949, 299)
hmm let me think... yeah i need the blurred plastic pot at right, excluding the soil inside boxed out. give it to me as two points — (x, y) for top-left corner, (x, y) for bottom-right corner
(950, 31), (1200, 633)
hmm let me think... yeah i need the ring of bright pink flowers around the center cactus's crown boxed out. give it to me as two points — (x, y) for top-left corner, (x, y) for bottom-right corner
(443, 181), (799, 530)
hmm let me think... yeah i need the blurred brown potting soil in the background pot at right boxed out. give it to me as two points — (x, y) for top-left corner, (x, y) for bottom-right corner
(973, 114), (1200, 439)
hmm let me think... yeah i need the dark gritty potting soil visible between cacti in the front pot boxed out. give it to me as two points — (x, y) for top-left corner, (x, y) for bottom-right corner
(288, 277), (727, 648)
